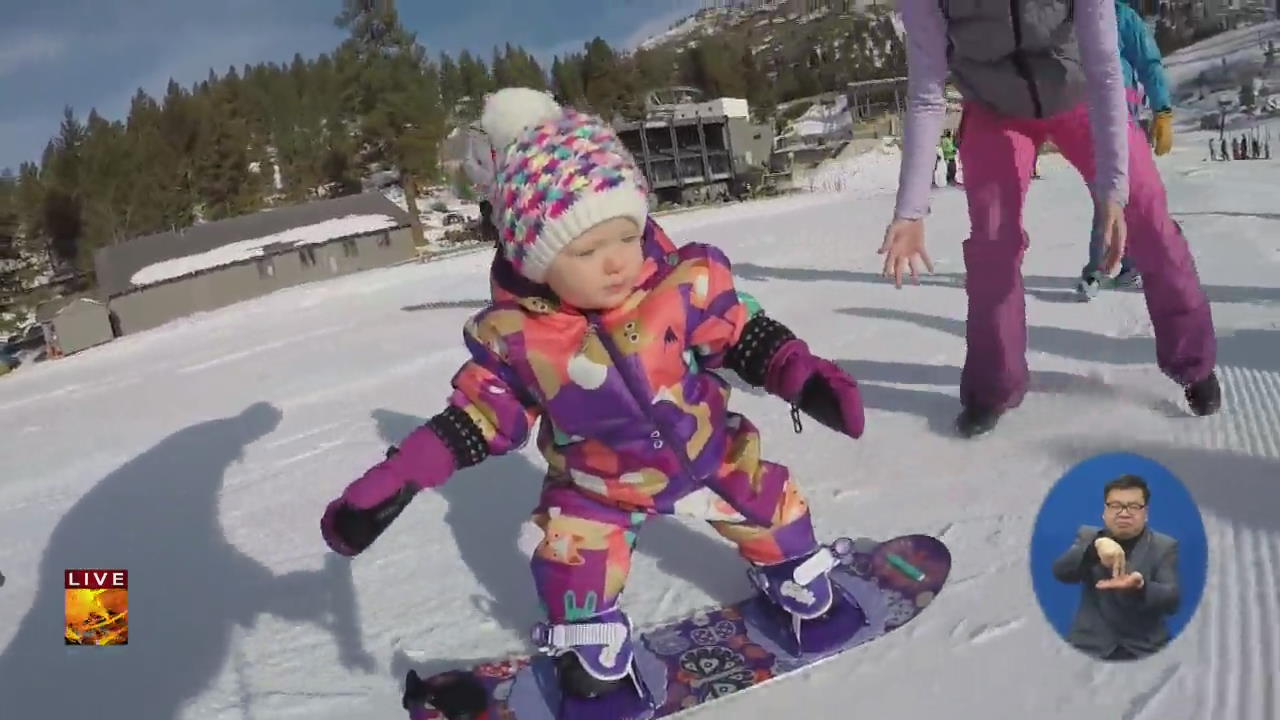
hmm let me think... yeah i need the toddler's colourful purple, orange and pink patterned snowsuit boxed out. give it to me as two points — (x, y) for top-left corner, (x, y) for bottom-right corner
(449, 219), (817, 623)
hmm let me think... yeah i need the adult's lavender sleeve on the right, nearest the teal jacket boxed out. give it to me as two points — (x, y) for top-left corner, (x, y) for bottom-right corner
(1075, 0), (1129, 205)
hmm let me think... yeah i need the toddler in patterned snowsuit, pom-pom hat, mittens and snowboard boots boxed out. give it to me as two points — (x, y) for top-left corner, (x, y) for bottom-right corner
(321, 88), (863, 719)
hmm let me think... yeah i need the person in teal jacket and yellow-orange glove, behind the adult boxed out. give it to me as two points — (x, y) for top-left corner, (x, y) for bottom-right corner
(1076, 0), (1174, 300)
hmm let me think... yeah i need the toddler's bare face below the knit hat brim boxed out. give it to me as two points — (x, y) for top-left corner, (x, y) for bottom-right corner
(547, 218), (644, 310)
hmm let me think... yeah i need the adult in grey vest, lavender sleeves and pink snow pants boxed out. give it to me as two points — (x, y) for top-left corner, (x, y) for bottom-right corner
(879, 0), (1221, 437)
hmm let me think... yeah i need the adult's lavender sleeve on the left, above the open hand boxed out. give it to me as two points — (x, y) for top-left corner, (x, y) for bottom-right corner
(893, 0), (957, 219)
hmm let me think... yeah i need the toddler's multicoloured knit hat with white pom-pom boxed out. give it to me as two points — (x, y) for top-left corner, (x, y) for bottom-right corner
(468, 87), (649, 283)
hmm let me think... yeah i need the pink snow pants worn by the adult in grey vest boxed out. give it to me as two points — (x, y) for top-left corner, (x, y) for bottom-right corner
(960, 102), (1217, 410)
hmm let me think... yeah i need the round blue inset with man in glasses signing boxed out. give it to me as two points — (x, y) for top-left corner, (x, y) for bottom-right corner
(1030, 452), (1208, 660)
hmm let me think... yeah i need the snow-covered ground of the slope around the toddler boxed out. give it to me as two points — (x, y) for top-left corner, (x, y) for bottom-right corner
(0, 25), (1280, 720)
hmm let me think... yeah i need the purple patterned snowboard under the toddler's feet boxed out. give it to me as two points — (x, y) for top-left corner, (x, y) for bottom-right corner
(403, 534), (951, 720)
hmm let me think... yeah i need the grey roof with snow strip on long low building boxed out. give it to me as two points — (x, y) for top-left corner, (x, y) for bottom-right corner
(93, 192), (410, 297)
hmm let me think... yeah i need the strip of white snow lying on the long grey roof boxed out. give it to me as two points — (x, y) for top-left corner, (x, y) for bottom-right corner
(129, 214), (399, 286)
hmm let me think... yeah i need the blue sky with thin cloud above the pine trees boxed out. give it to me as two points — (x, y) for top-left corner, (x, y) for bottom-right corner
(0, 0), (700, 170)
